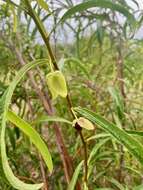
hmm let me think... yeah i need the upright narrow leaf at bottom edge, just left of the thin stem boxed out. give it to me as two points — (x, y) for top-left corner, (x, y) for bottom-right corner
(67, 161), (83, 190)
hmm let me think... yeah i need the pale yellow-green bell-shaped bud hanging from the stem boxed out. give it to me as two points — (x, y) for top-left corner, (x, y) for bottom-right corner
(46, 71), (67, 99)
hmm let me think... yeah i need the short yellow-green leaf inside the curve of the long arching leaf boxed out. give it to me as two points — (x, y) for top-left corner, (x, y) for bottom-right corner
(7, 110), (53, 172)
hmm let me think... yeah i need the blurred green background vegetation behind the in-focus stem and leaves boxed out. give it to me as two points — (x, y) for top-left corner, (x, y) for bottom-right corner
(0, 0), (143, 190)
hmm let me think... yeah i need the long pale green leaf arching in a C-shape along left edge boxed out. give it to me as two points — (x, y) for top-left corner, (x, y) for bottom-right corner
(0, 59), (48, 190)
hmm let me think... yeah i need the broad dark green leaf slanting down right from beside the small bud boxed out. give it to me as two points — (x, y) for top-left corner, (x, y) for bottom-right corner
(74, 107), (143, 164)
